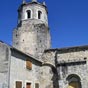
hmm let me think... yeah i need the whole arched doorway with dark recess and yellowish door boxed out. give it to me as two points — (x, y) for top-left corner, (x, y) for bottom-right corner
(66, 74), (82, 88)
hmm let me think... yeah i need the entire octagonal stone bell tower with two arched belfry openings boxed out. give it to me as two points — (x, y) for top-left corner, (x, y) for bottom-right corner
(13, 0), (51, 57)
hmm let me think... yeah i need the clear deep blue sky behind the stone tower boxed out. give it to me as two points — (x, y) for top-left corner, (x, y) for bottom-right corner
(0, 0), (88, 48)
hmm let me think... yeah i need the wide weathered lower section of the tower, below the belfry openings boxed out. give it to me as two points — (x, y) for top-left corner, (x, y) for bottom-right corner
(13, 20), (51, 57)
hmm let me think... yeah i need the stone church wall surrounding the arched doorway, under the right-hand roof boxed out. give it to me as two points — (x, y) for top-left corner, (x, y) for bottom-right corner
(57, 50), (88, 88)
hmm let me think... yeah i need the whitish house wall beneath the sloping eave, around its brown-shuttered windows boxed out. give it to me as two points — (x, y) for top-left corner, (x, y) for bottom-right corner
(10, 50), (41, 88)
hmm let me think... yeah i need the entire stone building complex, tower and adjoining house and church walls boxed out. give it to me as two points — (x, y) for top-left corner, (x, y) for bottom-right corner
(0, 0), (88, 88)
